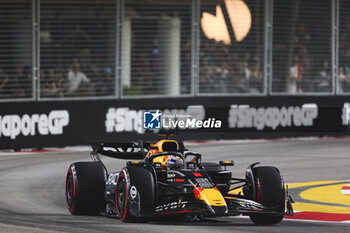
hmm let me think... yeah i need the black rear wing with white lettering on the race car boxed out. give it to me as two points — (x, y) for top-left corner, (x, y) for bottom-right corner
(91, 142), (150, 160)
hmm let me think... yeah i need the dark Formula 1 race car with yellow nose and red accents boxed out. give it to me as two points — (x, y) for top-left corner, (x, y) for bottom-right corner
(66, 139), (293, 224)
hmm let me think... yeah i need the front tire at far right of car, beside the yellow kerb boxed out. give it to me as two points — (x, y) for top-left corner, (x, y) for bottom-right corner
(249, 167), (285, 225)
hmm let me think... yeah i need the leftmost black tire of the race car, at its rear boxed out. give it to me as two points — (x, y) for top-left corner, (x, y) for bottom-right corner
(65, 162), (107, 215)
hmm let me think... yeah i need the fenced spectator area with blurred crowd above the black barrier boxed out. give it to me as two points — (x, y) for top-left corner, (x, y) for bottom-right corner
(0, 0), (350, 101)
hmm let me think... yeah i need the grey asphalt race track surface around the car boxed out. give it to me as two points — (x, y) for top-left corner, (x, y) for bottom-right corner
(0, 139), (350, 233)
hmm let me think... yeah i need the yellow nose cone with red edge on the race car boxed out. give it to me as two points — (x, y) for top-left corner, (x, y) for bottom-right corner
(194, 187), (228, 215)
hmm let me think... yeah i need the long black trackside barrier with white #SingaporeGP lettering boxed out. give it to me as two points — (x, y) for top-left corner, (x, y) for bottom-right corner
(0, 96), (350, 149)
